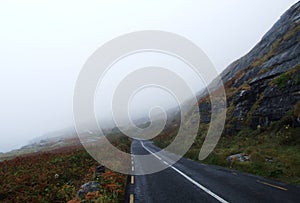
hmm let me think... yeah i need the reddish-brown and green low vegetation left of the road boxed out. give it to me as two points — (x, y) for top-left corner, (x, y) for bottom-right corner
(0, 134), (130, 203)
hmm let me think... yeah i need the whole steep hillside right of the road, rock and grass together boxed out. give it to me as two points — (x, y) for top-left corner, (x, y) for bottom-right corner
(155, 2), (300, 184)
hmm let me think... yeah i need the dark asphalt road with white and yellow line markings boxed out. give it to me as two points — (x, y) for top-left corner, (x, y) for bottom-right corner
(128, 140), (300, 203)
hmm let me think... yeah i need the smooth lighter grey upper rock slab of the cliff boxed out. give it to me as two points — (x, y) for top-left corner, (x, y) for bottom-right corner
(221, 2), (300, 85)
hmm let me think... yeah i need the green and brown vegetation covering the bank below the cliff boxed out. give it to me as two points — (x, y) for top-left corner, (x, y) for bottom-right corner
(154, 105), (300, 185)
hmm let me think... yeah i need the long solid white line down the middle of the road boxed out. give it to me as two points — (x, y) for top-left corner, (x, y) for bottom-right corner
(141, 142), (228, 203)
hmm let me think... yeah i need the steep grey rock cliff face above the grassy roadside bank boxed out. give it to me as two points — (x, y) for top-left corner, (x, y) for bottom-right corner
(199, 2), (300, 135)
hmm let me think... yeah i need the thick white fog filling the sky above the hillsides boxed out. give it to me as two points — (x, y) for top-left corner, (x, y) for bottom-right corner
(0, 0), (297, 152)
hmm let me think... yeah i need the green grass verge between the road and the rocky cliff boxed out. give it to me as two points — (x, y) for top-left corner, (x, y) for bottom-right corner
(195, 123), (300, 185)
